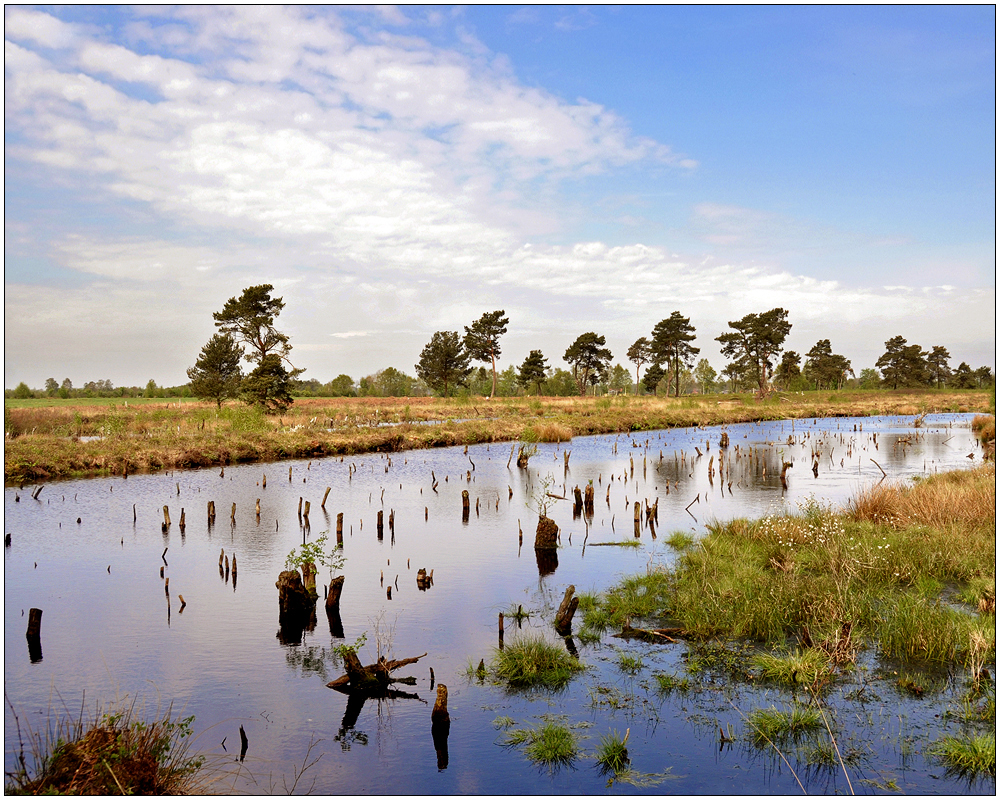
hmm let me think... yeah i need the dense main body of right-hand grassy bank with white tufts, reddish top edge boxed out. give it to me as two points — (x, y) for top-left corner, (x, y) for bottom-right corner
(581, 463), (996, 664)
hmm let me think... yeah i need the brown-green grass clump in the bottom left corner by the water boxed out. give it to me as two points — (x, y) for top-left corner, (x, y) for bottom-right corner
(4, 701), (209, 795)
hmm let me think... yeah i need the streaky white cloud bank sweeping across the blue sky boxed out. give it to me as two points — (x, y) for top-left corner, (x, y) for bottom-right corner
(5, 6), (992, 383)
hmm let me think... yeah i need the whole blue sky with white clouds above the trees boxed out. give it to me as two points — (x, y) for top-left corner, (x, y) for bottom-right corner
(4, 5), (996, 388)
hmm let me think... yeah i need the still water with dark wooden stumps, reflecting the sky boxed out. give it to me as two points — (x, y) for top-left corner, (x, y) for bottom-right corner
(4, 415), (995, 794)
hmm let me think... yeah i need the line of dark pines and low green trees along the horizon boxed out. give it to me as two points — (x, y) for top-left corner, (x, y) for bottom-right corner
(5, 284), (996, 412)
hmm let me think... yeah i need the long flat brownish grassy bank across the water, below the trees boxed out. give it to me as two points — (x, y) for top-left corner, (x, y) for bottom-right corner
(4, 390), (993, 483)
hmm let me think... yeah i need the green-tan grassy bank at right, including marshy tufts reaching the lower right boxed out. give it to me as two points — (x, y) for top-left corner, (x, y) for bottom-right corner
(579, 462), (996, 778)
